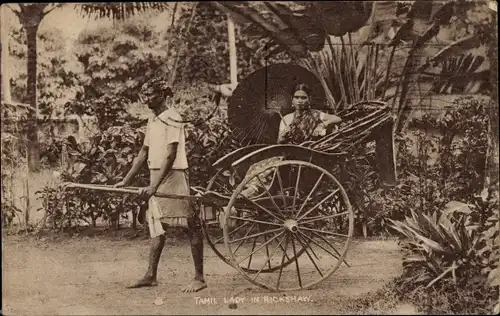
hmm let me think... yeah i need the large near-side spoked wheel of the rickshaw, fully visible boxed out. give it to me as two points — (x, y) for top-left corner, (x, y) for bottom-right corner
(223, 160), (354, 291)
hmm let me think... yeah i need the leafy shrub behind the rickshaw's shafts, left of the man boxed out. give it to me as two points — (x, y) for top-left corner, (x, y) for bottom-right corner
(37, 125), (147, 230)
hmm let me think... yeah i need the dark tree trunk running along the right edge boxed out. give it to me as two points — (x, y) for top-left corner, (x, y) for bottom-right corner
(482, 12), (499, 201)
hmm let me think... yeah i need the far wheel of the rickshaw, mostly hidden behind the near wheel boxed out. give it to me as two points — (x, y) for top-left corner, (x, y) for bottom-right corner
(201, 170), (305, 273)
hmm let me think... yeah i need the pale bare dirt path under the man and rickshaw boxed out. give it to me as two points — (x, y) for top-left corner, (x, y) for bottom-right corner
(2, 233), (412, 315)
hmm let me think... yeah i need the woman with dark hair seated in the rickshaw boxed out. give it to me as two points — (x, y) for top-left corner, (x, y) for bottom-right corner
(222, 84), (342, 226)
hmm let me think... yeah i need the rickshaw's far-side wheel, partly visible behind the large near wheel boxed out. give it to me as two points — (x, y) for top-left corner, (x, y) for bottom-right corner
(200, 169), (305, 273)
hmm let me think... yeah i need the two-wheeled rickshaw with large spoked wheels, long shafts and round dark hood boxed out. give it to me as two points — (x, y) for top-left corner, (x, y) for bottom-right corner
(64, 64), (397, 291)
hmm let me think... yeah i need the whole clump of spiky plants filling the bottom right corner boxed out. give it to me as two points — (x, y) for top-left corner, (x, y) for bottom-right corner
(391, 200), (499, 313)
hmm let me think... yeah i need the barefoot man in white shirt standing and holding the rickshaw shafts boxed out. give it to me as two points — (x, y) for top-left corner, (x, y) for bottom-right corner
(115, 77), (207, 292)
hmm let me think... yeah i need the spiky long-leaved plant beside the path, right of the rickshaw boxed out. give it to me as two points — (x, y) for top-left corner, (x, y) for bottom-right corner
(390, 201), (480, 287)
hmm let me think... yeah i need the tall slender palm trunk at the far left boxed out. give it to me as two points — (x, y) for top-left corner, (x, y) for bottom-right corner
(26, 24), (40, 171)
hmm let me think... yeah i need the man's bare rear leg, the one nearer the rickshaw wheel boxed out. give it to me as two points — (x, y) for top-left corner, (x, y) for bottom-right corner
(182, 217), (207, 293)
